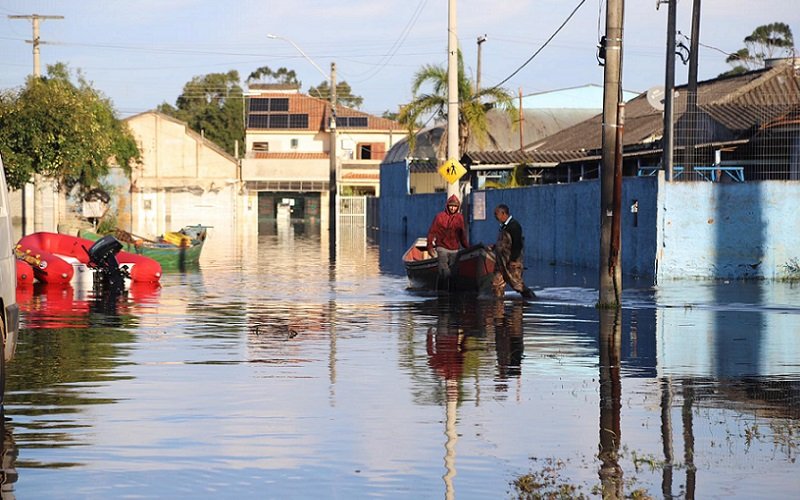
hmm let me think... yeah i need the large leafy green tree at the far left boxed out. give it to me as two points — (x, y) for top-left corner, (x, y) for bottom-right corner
(0, 63), (140, 192)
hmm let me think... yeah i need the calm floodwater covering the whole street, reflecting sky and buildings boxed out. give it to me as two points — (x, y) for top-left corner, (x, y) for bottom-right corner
(2, 224), (800, 499)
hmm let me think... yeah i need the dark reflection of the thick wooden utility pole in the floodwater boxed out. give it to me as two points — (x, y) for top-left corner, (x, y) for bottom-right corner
(598, 309), (624, 499)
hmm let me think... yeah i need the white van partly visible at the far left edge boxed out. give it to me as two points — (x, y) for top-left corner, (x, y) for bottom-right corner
(0, 154), (19, 405)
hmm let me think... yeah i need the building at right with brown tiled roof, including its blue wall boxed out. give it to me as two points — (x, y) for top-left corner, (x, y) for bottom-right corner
(379, 63), (800, 282)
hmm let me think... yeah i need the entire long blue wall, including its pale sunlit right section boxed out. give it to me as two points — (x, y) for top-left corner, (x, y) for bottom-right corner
(380, 158), (800, 282)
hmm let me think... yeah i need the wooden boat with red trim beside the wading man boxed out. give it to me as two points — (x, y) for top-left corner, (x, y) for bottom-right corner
(403, 238), (495, 295)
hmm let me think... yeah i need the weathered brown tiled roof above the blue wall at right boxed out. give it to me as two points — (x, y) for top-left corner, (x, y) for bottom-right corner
(531, 59), (800, 160)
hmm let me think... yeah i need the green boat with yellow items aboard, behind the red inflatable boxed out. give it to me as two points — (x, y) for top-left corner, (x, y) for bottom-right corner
(78, 225), (209, 270)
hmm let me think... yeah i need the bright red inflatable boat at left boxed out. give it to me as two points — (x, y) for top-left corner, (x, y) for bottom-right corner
(14, 232), (161, 286)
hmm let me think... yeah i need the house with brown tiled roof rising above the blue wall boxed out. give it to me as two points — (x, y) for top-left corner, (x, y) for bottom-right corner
(528, 61), (800, 182)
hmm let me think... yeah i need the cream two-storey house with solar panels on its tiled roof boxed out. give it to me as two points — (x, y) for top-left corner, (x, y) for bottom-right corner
(242, 84), (405, 220)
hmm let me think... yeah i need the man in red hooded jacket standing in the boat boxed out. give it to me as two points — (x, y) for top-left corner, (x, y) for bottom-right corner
(428, 195), (469, 278)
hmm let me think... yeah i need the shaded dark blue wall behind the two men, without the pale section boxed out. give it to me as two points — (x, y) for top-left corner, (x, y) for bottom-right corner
(380, 163), (658, 276)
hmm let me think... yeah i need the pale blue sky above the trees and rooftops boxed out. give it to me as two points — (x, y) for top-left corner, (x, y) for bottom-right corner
(0, 0), (800, 117)
